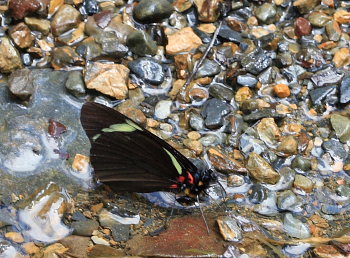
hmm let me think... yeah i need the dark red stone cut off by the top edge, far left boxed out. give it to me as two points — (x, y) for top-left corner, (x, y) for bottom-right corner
(9, 0), (40, 19)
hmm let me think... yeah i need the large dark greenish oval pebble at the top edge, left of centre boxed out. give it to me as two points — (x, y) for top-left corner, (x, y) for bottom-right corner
(134, 0), (174, 23)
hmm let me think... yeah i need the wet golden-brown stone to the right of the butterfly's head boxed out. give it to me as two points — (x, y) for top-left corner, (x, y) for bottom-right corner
(246, 152), (280, 184)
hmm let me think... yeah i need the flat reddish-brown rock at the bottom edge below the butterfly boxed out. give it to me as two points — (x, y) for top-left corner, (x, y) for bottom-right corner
(126, 216), (225, 257)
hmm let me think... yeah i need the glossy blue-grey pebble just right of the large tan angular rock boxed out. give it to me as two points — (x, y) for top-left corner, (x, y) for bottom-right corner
(128, 57), (164, 85)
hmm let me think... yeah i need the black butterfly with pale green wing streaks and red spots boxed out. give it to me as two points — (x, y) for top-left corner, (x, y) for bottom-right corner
(80, 102), (215, 198)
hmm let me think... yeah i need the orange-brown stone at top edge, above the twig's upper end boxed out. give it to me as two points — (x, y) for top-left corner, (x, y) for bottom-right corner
(194, 0), (221, 22)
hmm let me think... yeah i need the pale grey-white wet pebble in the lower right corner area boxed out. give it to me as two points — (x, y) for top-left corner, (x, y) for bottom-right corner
(283, 213), (311, 239)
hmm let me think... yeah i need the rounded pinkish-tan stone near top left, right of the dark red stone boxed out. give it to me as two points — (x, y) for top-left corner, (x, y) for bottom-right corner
(51, 4), (81, 36)
